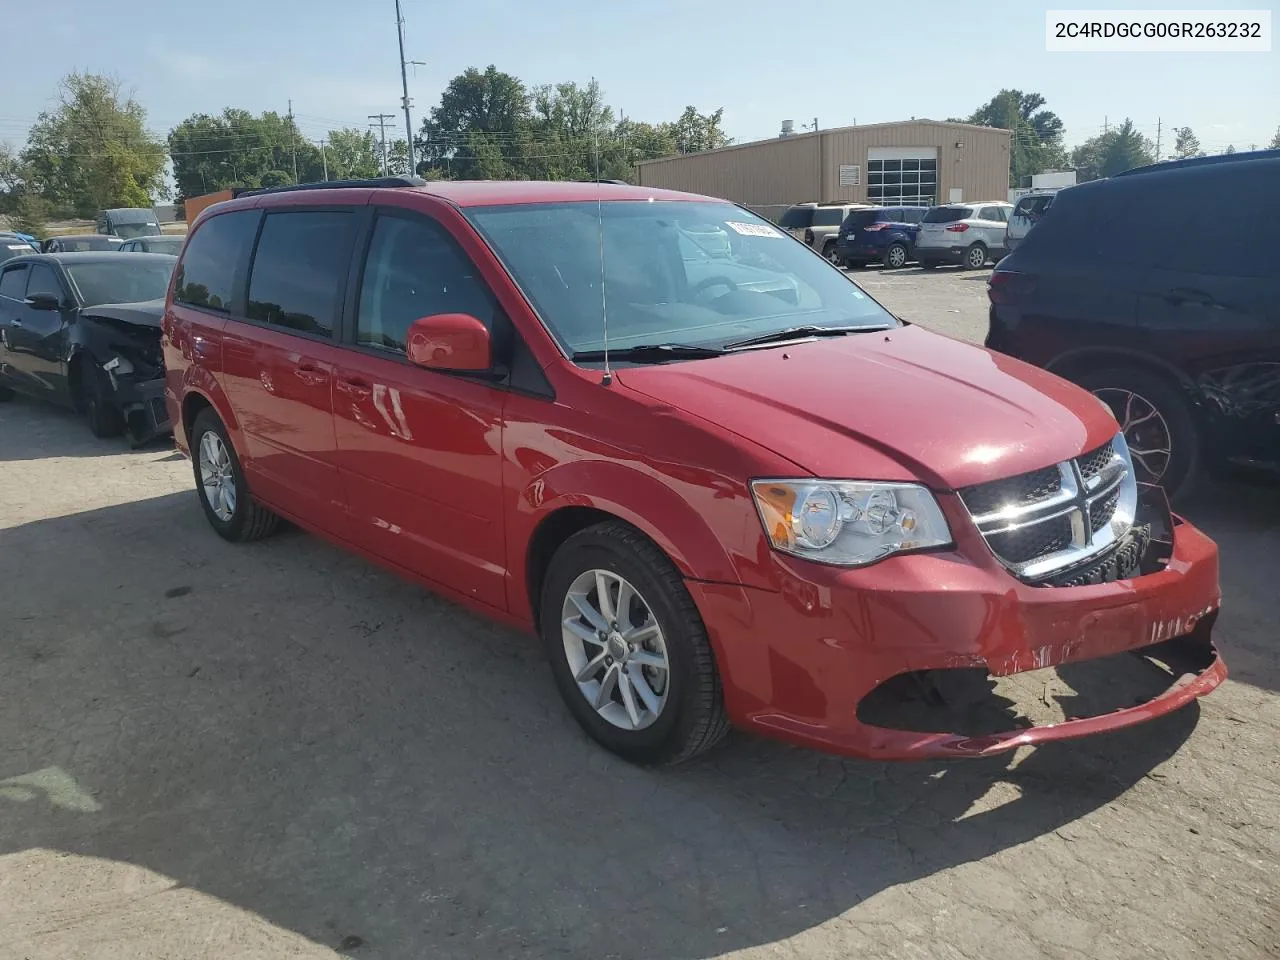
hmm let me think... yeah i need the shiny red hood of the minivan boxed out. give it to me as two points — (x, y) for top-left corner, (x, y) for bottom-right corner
(617, 326), (1119, 489)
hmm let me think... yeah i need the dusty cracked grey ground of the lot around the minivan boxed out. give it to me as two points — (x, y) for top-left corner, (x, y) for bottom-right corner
(0, 269), (1280, 960)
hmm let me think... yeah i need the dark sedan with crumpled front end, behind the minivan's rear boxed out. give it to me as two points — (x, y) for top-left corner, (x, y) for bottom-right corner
(0, 252), (178, 445)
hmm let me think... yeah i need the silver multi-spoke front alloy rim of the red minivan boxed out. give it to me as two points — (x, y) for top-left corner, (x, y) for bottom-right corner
(561, 570), (671, 730)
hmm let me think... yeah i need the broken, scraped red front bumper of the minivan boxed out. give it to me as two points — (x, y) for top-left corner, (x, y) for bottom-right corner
(689, 490), (1226, 759)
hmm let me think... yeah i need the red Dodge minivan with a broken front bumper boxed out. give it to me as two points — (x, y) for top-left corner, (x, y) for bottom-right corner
(164, 178), (1226, 763)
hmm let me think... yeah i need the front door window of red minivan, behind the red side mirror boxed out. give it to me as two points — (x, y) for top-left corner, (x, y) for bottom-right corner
(356, 216), (497, 352)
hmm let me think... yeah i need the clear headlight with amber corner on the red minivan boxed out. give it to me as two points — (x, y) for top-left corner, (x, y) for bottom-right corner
(751, 480), (951, 567)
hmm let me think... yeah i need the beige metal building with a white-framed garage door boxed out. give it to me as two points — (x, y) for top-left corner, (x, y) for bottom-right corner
(636, 120), (1010, 219)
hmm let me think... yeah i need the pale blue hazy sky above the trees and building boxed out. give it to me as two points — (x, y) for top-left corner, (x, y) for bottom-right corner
(0, 0), (1280, 155)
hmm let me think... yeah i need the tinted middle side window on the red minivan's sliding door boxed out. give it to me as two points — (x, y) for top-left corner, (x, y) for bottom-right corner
(248, 210), (356, 337)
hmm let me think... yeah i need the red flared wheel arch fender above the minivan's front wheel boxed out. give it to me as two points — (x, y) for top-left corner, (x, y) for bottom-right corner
(509, 460), (750, 609)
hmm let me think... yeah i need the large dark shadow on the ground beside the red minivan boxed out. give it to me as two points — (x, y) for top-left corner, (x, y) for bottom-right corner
(0, 493), (1199, 959)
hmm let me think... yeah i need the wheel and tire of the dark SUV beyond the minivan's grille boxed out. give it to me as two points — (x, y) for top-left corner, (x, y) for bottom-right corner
(1071, 366), (1203, 497)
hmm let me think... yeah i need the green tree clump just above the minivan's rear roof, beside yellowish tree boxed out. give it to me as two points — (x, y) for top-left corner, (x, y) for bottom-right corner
(169, 108), (324, 197)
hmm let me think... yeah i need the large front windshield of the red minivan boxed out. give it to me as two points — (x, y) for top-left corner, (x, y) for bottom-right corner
(467, 201), (897, 355)
